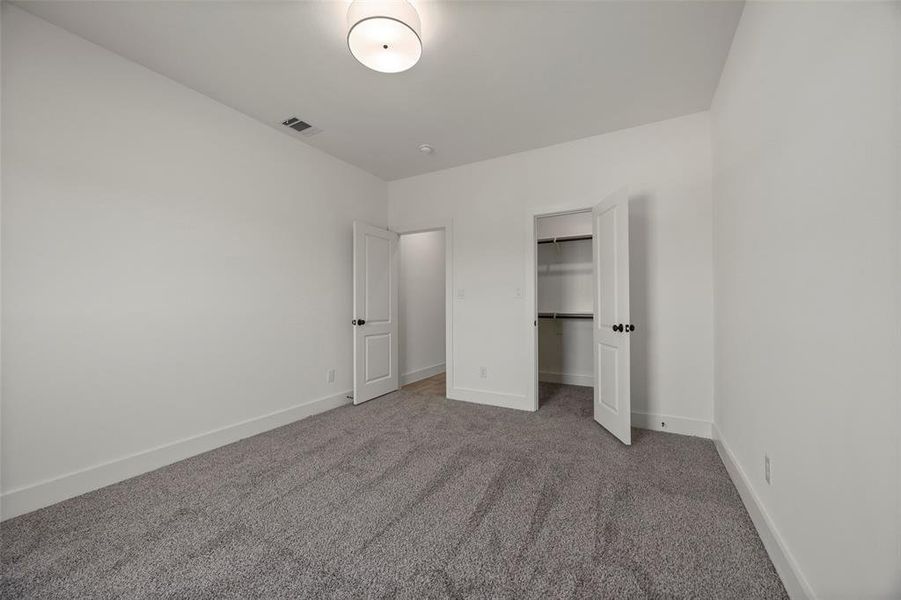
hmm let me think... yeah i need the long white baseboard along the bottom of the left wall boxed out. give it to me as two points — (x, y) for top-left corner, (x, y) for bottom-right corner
(0, 391), (351, 520)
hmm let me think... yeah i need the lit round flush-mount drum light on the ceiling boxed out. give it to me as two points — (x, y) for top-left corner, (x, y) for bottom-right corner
(347, 0), (422, 73)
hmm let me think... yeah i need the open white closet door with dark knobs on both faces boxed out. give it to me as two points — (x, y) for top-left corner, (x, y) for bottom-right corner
(592, 190), (634, 444)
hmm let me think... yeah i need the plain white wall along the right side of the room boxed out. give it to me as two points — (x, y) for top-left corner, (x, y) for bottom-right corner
(712, 2), (901, 598)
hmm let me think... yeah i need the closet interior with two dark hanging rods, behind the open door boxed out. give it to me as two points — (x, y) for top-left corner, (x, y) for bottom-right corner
(537, 211), (594, 402)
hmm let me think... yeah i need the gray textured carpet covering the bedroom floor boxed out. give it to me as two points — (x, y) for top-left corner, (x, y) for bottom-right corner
(0, 385), (787, 600)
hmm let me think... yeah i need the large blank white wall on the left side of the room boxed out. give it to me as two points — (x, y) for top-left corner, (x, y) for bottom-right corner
(2, 3), (387, 516)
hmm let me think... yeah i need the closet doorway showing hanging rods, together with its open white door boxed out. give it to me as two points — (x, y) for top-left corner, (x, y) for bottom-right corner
(527, 189), (635, 445)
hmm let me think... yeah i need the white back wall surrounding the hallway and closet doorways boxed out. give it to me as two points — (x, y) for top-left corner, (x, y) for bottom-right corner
(388, 114), (713, 429)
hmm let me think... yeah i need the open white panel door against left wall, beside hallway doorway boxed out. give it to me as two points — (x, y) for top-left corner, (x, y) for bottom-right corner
(353, 221), (398, 404)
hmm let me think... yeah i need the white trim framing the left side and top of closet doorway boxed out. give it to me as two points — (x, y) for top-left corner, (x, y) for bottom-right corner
(525, 200), (596, 411)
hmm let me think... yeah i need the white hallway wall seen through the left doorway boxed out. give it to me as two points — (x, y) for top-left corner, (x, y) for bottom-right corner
(398, 229), (446, 383)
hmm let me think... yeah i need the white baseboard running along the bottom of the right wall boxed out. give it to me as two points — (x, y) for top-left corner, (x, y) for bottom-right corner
(712, 423), (816, 600)
